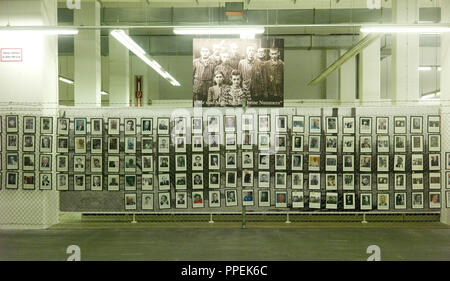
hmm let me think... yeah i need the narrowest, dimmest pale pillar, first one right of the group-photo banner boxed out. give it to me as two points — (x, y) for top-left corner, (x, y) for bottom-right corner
(339, 50), (356, 103)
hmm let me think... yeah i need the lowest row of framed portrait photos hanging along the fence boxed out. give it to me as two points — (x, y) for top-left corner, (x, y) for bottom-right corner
(120, 189), (450, 211)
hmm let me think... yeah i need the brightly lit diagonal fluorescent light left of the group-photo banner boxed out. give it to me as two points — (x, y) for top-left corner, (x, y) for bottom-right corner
(111, 29), (180, 86)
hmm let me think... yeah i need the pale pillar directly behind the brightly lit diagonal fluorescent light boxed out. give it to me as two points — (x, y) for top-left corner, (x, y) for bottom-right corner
(108, 32), (130, 106)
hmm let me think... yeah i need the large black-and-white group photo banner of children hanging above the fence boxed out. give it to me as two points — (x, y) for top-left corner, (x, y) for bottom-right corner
(192, 38), (284, 107)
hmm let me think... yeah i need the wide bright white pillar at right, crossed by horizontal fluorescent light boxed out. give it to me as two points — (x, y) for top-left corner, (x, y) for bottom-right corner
(391, 0), (420, 102)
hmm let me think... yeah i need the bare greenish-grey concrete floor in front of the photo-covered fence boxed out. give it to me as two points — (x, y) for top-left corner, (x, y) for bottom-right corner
(0, 223), (450, 261)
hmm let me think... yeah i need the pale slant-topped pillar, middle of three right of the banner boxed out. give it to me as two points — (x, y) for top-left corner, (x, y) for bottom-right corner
(359, 39), (381, 102)
